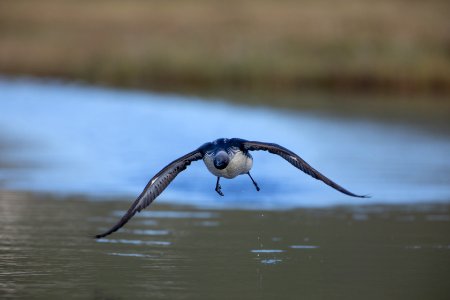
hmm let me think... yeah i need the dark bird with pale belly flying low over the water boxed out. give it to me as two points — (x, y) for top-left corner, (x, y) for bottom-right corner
(95, 138), (368, 238)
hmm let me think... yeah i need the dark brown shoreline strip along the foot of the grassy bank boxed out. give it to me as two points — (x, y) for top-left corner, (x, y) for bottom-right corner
(0, 66), (450, 96)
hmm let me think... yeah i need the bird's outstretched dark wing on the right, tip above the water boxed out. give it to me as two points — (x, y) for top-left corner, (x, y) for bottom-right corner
(242, 141), (368, 198)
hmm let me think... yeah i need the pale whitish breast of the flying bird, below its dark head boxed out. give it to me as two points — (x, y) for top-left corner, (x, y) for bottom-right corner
(203, 152), (253, 179)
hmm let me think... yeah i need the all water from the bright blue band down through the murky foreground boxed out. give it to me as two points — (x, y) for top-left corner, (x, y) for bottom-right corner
(0, 79), (450, 299)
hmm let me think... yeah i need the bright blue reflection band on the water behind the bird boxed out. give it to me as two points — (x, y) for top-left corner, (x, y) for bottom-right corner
(0, 80), (450, 209)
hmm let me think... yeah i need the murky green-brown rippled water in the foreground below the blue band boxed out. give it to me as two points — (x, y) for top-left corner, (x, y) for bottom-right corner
(0, 192), (450, 299)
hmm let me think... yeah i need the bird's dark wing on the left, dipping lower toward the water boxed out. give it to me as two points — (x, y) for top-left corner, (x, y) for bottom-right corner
(95, 148), (203, 238)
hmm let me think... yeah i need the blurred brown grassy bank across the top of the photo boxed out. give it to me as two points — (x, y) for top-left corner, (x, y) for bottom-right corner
(0, 0), (450, 92)
